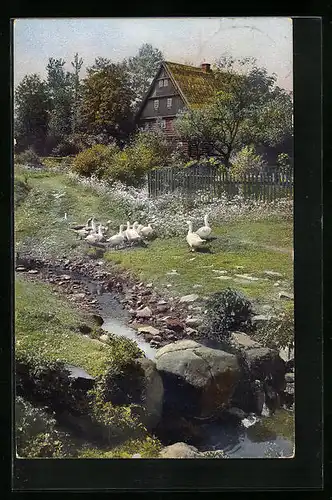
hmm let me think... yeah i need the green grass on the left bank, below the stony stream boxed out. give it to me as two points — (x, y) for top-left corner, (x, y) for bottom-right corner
(15, 275), (112, 376)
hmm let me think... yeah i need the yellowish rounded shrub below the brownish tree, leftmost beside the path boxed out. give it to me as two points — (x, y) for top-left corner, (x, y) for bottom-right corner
(72, 144), (119, 179)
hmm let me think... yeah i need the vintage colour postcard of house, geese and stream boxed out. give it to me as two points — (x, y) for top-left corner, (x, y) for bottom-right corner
(13, 17), (296, 460)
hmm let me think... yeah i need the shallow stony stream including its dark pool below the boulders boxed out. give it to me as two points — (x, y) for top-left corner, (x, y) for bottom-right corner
(16, 254), (293, 458)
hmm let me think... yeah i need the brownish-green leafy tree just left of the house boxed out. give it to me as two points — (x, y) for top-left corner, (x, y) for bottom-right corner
(80, 63), (133, 139)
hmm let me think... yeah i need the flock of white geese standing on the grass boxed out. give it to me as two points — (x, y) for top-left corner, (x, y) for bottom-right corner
(70, 215), (212, 251)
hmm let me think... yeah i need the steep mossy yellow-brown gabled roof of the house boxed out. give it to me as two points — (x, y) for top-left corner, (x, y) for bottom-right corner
(136, 61), (218, 117)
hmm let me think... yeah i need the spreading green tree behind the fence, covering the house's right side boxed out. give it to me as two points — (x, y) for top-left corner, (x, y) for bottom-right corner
(176, 58), (292, 168)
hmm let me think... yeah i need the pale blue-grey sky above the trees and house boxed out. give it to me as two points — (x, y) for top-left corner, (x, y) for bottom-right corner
(14, 17), (293, 90)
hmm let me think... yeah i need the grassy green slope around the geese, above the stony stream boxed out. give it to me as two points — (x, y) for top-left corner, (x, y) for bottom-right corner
(15, 168), (293, 306)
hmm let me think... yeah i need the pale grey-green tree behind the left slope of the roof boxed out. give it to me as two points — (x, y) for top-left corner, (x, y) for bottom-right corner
(127, 43), (164, 109)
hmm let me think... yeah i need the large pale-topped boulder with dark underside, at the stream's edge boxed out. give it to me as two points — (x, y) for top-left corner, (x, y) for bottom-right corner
(155, 340), (240, 419)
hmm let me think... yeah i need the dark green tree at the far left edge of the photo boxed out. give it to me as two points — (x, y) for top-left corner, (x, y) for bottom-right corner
(14, 74), (50, 154)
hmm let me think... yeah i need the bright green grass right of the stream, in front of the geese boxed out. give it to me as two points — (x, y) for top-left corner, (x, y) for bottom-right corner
(105, 232), (293, 306)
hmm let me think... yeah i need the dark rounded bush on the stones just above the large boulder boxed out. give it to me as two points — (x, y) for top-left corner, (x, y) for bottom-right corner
(205, 288), (253, 341)
